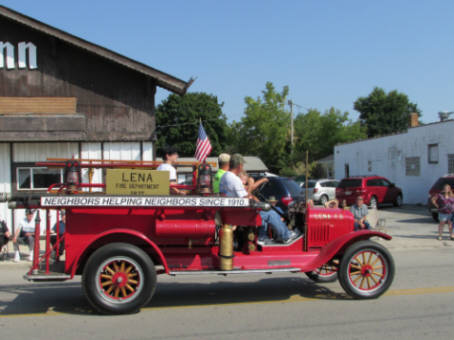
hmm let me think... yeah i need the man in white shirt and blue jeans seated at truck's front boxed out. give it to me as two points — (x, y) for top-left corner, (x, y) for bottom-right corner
(219, 153), (299, 245)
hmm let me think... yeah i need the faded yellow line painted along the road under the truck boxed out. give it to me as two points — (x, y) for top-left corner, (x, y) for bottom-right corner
(0, 286), (454, 318)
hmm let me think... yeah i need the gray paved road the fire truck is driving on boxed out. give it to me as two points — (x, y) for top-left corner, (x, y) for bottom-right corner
(0, 248), (454, 340)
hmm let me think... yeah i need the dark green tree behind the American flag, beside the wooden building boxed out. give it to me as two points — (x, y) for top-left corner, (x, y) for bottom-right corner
(156, 92), (228, 157)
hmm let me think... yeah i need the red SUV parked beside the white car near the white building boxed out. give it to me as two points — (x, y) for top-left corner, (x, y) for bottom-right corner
(336, 176), (403, 208)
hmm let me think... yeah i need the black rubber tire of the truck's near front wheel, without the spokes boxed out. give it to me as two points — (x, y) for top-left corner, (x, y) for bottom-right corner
(338, 240), (395, 299)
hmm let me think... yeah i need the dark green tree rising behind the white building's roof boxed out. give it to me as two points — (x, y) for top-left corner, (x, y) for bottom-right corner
(354, 87), (420, 137)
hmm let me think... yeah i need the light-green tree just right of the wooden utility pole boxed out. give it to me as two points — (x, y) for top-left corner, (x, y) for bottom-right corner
(294, 108), (366, 163)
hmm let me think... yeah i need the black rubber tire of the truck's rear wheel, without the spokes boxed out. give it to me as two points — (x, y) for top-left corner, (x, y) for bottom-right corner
(82, 243), (156, 314)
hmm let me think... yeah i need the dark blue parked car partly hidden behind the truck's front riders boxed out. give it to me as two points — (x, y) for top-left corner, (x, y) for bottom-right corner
(255, 176), (302, 213)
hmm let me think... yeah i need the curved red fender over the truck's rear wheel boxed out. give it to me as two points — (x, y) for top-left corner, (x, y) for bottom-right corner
(71, 228), (170, 277)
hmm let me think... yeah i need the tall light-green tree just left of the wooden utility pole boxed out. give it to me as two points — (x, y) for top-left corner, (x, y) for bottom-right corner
(237, 82), (290, 171)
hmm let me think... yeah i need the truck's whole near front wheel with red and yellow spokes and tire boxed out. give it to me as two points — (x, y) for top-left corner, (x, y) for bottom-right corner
(339, 241), (395, 299)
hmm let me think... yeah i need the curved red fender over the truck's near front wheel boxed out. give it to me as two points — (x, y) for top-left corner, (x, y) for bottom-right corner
(310, 230), (392, 270)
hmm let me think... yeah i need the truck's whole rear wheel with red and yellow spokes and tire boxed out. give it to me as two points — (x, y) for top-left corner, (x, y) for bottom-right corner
(82, 243), (156, 314)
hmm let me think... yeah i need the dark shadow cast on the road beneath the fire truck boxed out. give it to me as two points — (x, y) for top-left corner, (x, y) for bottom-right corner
(0, 277), (351, 317)
